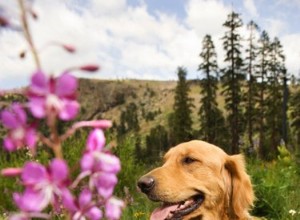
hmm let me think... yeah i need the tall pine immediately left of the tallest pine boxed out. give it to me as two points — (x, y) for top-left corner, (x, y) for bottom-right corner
(198, 35), (224, 146)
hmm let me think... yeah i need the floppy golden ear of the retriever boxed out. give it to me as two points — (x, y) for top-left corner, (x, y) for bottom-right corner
(225, 155), (254, 219)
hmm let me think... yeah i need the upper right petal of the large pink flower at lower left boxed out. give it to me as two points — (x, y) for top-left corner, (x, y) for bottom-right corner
(50, 159), (69, 182)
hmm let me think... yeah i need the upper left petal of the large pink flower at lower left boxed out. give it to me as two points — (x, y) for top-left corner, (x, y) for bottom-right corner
(22, 162), (48, 185)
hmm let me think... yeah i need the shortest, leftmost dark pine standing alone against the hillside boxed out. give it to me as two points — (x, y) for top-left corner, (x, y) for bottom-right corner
(172, 67), (193, 144)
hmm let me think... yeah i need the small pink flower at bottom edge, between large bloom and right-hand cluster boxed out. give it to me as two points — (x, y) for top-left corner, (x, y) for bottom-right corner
(63, 189), (102, 220)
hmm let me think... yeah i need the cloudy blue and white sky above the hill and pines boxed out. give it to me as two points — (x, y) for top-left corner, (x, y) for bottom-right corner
(0, 0), (300, 89)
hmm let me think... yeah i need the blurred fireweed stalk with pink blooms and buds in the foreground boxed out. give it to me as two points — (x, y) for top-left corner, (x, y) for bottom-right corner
(0, 0), (124, 220)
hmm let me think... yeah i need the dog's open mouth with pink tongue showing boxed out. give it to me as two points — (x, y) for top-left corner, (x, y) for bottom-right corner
(150, 195), (204, 220)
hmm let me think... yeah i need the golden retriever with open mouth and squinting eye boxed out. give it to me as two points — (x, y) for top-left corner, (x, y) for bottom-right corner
(137, 140), (255, 220)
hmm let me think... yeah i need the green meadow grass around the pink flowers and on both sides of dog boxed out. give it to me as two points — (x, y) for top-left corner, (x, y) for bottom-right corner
(0, 132), (300, 220)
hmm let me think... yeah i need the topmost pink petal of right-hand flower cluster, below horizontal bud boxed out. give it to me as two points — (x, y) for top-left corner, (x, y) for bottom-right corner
(86, 129), (105, 151)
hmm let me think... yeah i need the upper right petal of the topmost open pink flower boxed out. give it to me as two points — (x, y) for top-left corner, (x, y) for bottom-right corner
(55, 73), (77, 98)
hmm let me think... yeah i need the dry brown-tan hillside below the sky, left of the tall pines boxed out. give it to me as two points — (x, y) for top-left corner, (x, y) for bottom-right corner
(79, 79), (204, 134)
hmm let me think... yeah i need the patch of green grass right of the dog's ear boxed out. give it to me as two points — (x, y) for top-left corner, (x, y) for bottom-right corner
(248, 156), (300, 220)
